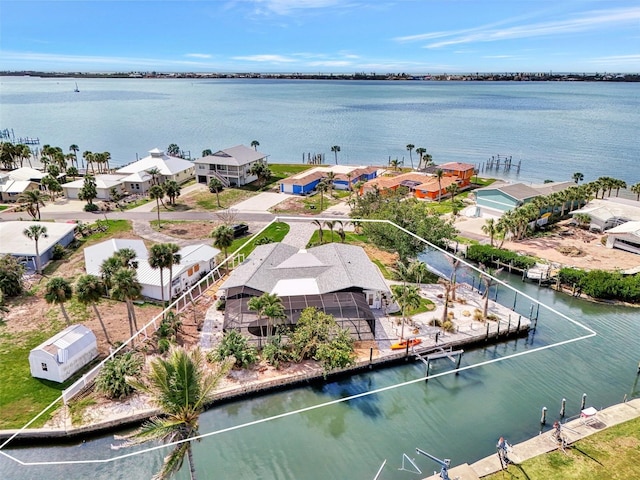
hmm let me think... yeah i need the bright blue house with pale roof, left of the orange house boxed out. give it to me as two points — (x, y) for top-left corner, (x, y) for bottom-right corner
(280, 165), (380, 195)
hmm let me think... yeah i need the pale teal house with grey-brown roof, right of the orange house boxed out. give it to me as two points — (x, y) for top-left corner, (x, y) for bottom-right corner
(475, 182), (575, 216)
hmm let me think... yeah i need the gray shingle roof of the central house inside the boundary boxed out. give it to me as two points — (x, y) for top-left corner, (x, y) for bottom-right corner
(220, 243), (388, 295)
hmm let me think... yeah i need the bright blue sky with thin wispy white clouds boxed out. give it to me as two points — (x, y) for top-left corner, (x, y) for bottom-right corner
(0, 0), (640, 74)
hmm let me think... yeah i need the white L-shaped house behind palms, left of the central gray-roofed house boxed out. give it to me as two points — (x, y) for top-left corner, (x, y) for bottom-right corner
(84, 239), (220, 300)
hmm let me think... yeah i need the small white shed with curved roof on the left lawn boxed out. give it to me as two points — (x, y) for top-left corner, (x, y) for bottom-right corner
(29, 325), (98, 383)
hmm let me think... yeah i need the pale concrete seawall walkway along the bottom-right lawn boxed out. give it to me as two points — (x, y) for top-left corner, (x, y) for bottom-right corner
(424, 398), (640, 480)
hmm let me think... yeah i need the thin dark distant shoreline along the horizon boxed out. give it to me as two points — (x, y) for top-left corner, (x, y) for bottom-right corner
(0, 70), (640, 83)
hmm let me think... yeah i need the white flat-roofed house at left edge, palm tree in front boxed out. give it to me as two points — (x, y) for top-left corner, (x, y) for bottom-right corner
(0, 221), (76, 270)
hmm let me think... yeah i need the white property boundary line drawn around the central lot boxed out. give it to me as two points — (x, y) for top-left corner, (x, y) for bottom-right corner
(0, 216), (597, 466)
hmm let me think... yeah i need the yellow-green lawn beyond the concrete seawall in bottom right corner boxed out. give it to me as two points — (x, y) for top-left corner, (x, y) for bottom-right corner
(483, 418), (640, 480)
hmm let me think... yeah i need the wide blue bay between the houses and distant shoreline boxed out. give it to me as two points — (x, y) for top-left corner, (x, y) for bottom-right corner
(0, 77), (640, 184)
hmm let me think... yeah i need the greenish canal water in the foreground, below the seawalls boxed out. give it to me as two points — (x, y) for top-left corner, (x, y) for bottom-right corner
(0, 254), (640, 480)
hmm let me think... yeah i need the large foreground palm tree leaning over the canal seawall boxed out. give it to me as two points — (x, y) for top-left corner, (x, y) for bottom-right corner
(118, 348), (232, 480)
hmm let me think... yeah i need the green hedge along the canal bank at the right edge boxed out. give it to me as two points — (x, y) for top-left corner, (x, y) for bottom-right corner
(559, 268), (640, 303)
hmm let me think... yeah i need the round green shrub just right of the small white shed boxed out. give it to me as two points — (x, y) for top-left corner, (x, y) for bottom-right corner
(96, 352), (144, 400)
